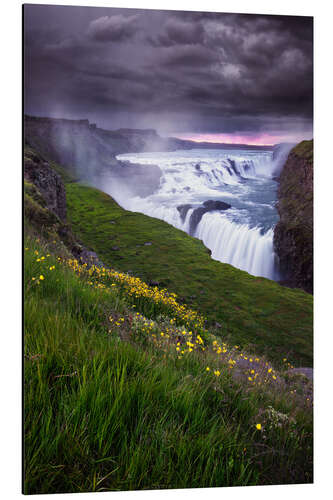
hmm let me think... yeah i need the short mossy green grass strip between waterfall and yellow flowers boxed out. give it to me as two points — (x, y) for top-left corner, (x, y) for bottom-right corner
(66, 183), (313, 366)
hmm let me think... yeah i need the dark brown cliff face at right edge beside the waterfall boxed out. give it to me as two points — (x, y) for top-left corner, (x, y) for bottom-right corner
(274, 140), (313, 293)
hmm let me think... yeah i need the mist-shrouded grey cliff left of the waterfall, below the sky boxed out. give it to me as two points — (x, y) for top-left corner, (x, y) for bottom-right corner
(24, 116), (163, 196)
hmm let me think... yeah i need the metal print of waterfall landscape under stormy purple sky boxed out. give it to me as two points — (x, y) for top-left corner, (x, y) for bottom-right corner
(23, 4), (313, 494)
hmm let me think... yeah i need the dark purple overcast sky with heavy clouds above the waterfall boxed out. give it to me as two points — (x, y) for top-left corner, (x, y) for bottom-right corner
(24, 5), (313, 144)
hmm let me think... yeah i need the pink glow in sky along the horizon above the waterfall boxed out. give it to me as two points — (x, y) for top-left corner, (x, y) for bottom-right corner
(170, 133), (312, 146)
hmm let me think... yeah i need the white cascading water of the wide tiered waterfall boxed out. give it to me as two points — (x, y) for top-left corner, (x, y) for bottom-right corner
(107, 149), (279, 279)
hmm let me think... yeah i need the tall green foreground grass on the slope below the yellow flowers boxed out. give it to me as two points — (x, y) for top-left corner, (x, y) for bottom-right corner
(24, 238), (312, 494)
